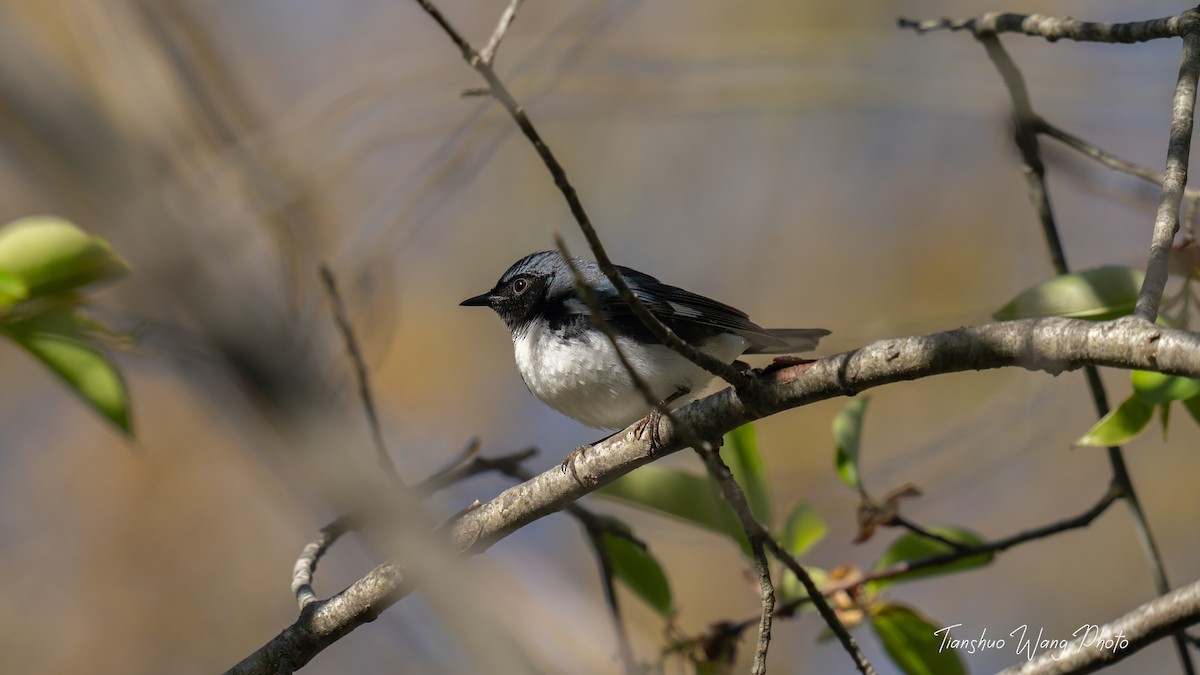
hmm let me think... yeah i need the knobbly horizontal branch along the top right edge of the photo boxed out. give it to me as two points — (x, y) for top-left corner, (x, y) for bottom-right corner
(896, 10), (1200, 43)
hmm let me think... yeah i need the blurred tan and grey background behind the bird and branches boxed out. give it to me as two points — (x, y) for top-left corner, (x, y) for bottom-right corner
(0, 0), (1200, 674)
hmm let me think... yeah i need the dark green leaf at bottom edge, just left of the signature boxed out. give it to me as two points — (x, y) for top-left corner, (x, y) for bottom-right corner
(871, 603), (966, 675)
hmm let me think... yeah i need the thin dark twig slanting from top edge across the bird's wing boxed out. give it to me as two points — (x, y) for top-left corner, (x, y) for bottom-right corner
(416, 0), (754, 389)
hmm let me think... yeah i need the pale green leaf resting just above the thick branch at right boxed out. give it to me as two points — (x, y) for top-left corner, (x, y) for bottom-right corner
(992, 265), (1146, 321)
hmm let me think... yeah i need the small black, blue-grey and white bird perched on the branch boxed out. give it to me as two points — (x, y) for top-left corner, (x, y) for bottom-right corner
(460, 251), (829, 430)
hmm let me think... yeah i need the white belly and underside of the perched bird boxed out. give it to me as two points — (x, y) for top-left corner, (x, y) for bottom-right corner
(514, 322), (749, 429)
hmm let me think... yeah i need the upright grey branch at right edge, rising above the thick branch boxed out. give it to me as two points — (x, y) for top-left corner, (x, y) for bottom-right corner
(1134, 30), (1200, 321)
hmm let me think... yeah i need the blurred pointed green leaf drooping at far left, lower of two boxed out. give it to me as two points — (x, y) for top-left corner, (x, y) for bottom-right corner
(0, 306), (133, 435)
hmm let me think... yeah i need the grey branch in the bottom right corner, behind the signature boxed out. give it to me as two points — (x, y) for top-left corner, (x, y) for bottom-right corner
(1000, 571), (1200, 675)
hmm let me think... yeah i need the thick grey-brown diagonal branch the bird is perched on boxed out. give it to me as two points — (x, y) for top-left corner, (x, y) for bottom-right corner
(223, 317), (1200, 674)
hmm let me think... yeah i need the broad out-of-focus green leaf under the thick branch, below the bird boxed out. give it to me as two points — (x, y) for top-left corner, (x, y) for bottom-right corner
(596, 464), (750, 551)
